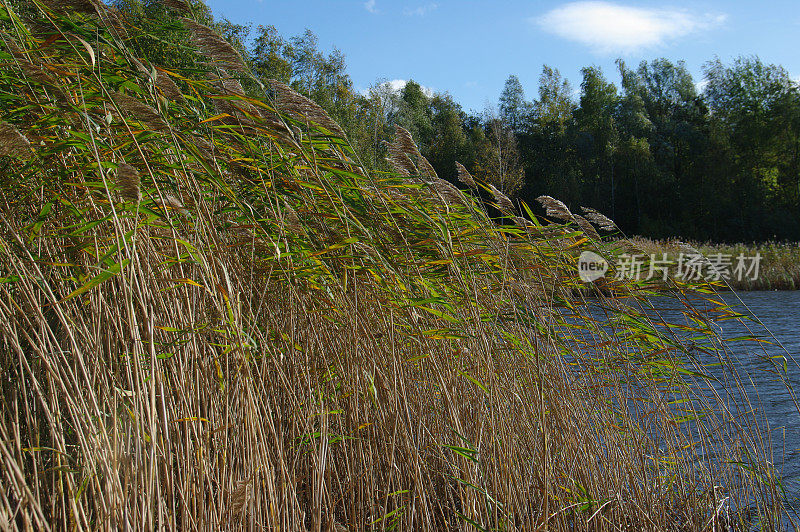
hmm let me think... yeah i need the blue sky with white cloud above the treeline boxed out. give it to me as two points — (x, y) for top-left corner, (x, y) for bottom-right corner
(207, 0), (800, 111)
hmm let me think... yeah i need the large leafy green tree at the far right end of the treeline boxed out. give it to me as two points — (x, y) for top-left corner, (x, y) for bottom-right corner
(704, 57), (800, 238)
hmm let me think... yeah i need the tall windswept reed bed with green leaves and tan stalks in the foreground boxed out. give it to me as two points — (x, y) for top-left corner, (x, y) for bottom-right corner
(0, 0), (792, 531)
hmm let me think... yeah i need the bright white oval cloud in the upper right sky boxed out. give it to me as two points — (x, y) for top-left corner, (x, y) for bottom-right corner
(533, 2), (727, 54)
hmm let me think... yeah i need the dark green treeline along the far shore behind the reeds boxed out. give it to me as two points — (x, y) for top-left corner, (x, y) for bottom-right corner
(116, 0), (800, 241)
